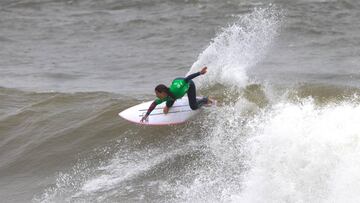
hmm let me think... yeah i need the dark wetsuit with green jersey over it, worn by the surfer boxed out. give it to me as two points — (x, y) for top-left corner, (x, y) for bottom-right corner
(146, 72), (208, 116)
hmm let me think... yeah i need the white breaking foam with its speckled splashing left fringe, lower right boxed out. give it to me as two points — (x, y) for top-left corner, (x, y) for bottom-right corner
(167, 94), (360, 203)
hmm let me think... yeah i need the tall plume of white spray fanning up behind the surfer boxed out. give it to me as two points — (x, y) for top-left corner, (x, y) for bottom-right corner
(188, 5), (283, 87)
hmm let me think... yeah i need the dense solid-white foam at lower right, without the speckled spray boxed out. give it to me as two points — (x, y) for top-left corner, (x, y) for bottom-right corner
(232, 101), (360, 202)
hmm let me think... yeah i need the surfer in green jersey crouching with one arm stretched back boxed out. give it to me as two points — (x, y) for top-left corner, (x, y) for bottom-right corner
(140, 67), (211, 122)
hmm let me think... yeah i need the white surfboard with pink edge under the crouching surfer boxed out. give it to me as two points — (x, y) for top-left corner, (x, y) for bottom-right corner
(119, 97), (214, 125)
